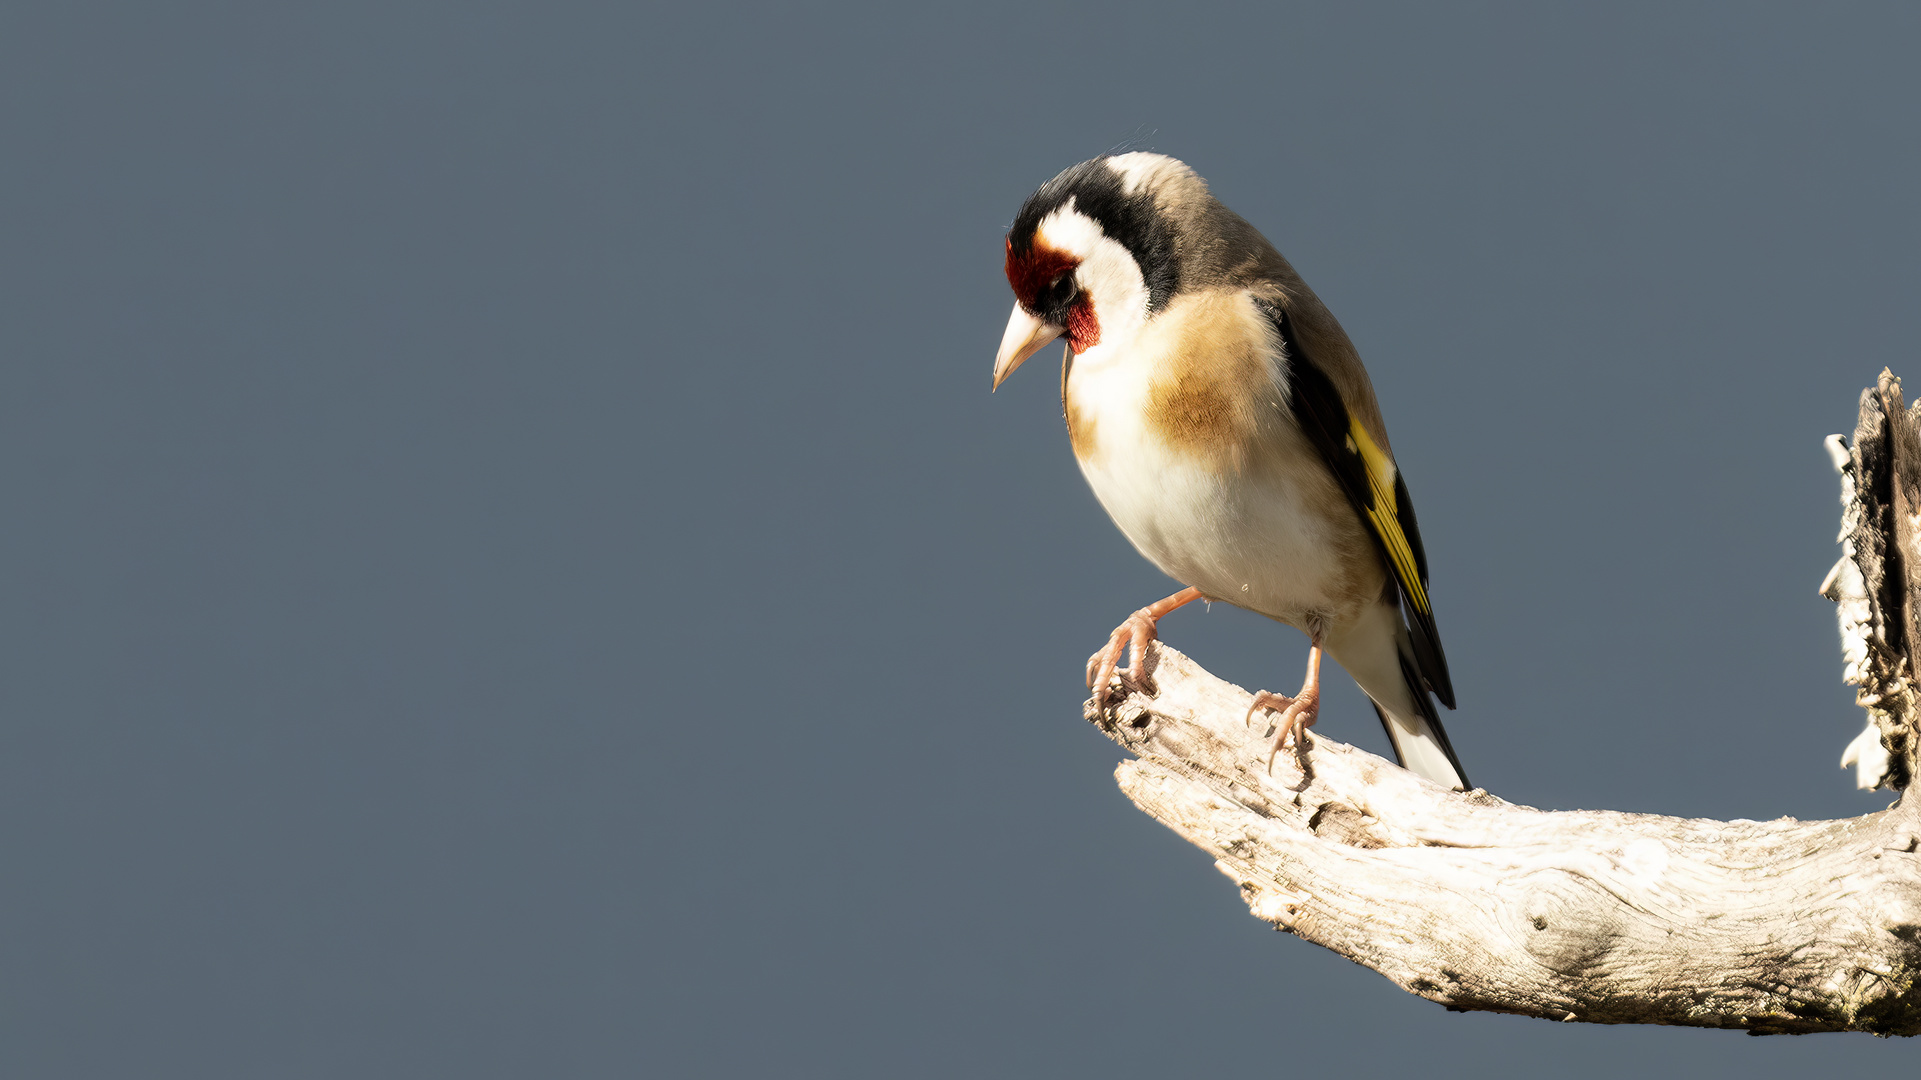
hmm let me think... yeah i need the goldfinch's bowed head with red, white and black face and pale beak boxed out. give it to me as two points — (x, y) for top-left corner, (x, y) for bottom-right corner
(993, 154), (1212, 388)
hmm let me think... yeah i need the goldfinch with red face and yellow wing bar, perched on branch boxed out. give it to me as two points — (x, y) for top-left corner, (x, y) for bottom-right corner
(993, 152), (1468, 790)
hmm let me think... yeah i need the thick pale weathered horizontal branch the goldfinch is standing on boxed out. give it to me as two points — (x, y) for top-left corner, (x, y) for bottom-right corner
(1087, 644), (1921, 1034)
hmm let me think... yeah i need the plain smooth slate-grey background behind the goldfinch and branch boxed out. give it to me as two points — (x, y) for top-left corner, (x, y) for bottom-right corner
(0, 2), (1921, 1078)
